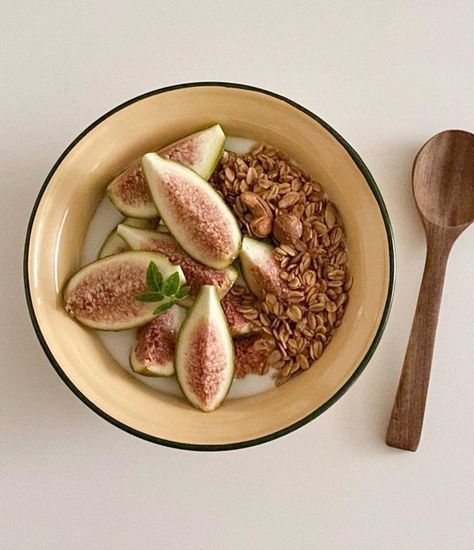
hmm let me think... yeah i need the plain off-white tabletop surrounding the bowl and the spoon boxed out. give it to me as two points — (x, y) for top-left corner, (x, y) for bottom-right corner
(0, 0), (474, 550)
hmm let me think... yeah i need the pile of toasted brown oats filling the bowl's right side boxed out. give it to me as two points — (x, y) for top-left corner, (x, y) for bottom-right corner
(210, 145), (352, 386)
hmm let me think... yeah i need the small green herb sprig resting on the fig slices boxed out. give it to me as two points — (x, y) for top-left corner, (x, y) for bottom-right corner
(135, 262), (189, 315)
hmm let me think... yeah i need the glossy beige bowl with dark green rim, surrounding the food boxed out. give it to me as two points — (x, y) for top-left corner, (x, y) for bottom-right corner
(24, 83), (394, 450)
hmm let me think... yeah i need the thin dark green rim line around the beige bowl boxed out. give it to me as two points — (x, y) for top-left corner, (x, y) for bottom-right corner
(23, 82), (395, 451)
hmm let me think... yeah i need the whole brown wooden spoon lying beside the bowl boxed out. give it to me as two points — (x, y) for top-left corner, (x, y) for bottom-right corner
(386, 130), (474, 451)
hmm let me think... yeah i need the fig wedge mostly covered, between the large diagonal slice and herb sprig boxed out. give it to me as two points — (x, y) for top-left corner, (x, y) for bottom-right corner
(117, 224), (237, 307)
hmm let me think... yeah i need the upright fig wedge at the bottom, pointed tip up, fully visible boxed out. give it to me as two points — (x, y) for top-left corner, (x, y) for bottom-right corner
(175, 285), (234, 412)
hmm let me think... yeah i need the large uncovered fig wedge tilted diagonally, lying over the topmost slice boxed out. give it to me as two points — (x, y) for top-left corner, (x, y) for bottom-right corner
(142, 153), (242, 269)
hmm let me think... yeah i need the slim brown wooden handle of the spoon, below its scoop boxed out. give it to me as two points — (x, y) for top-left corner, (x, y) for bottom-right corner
(386, 226), (455, 451)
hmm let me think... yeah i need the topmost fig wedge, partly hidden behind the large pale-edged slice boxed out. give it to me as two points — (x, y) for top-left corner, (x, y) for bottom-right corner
(107, 124), (225, 218)
